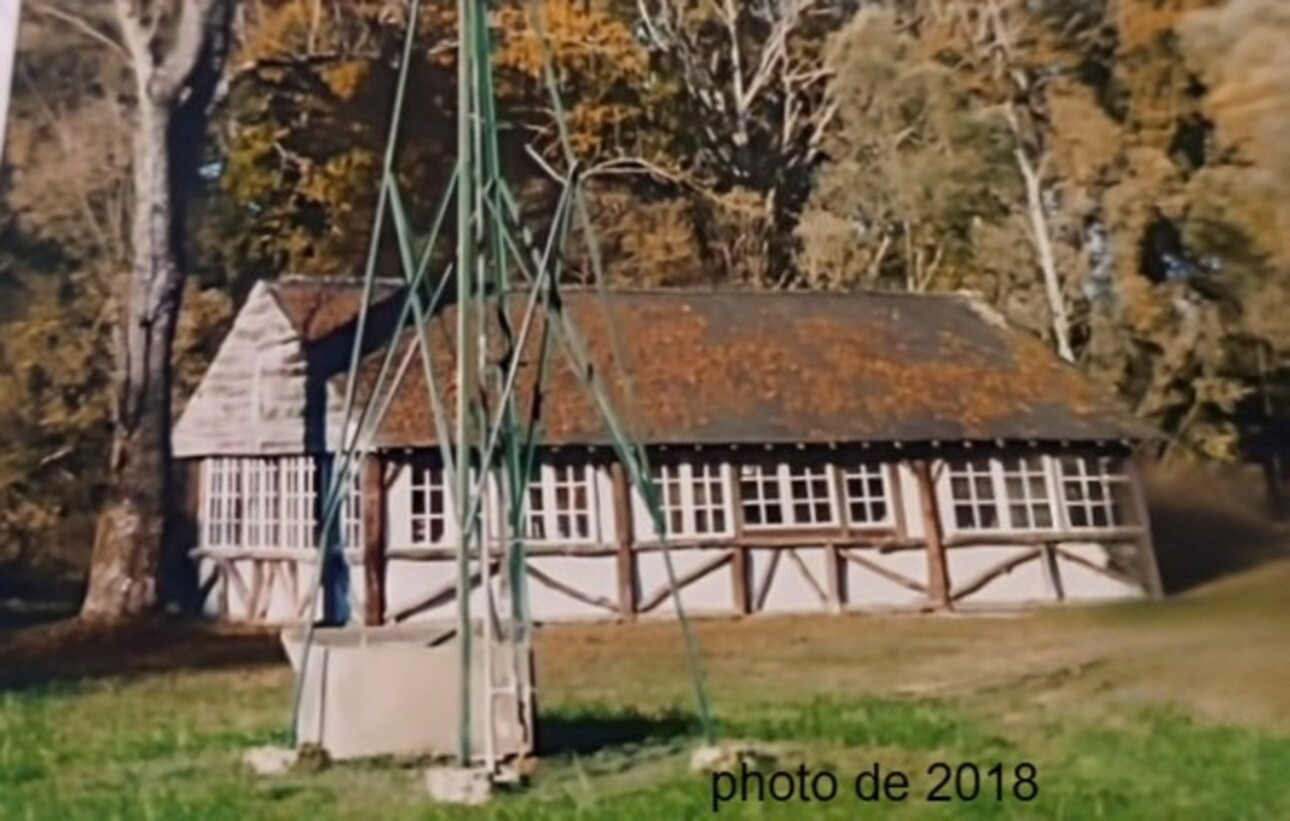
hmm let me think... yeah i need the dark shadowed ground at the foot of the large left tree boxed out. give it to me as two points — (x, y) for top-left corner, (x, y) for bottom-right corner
(0, 618), (285, 691)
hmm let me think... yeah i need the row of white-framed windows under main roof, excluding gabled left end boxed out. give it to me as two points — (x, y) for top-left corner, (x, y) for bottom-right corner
(392, 456), (1130, 545)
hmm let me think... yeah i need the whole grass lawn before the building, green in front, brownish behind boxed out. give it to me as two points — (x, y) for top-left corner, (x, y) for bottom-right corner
(0, 562), (1290, 821)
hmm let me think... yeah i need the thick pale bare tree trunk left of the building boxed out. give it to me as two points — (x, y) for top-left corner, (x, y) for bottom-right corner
(81, 98), (183, 618)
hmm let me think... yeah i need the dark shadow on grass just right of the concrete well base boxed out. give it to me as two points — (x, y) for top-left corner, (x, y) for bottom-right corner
(538, 706), (699, 756)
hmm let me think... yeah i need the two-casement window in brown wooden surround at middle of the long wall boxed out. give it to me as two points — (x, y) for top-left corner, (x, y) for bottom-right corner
(739, 463), (836, 528)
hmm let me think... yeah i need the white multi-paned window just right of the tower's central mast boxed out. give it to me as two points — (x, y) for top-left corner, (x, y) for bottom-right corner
(524, 462), (603, 545)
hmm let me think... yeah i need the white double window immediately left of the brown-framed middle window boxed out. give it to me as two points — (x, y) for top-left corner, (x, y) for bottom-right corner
(632, 460), (734, 542)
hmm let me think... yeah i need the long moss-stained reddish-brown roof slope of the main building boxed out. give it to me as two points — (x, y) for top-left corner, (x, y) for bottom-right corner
(327, 289), (1151, 447)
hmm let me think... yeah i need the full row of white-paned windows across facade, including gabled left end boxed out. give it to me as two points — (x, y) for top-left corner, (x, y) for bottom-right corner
(203, 456), (1130, 547)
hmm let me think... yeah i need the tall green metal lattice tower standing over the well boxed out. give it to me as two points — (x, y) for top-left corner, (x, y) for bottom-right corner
(293, 0), (712, 769)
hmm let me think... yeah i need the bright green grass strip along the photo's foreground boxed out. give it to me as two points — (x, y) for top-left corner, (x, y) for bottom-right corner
(0, 675), (1290, 820)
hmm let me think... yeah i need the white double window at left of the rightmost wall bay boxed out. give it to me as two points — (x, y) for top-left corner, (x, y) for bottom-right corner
(937, 454), (1066, 534)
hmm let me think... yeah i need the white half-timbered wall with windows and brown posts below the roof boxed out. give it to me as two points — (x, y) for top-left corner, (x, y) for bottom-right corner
(184, 448), (1158, 622)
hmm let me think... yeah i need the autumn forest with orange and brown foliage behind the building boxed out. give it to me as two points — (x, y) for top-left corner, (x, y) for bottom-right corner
(0, 0), (1290, 586)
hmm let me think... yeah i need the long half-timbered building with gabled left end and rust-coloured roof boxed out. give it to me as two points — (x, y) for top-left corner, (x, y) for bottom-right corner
(166, 278), (1161, 623)
